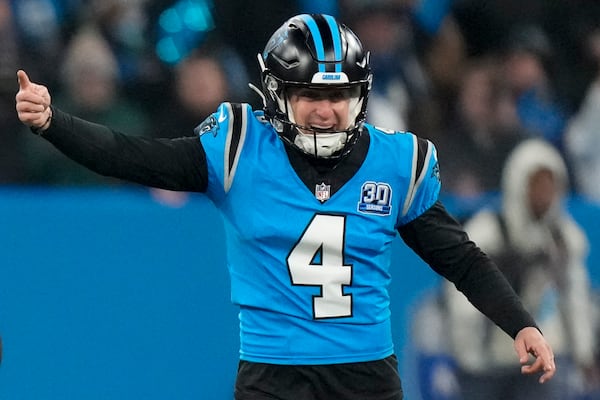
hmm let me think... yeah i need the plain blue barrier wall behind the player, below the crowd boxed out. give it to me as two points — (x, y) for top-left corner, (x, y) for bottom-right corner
(0, 188), (600, 400)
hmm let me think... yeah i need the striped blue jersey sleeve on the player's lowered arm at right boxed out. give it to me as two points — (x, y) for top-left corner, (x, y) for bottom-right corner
(398, 135), (441, 226)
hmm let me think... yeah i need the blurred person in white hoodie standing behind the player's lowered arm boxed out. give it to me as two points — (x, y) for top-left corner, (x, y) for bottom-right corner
(444, 139), (597, 400)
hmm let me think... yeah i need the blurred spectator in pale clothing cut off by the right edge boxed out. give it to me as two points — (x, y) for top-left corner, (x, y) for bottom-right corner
(565, 26), (600, 204)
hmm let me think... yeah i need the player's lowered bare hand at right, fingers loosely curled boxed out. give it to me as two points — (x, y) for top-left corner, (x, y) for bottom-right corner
(514, 327), (556, 383)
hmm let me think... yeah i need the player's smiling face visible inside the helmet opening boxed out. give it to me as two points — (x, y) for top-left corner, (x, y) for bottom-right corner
(290, 88), (352, 133)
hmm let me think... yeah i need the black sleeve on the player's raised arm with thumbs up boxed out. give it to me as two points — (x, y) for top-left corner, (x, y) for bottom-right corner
(42, 107), (208, 192)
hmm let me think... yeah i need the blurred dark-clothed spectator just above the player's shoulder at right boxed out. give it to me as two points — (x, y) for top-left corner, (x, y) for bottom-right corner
(431, 57), (522, 199)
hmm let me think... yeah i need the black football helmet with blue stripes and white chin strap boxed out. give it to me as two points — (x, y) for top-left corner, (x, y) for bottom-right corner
(258, 14), (372, 159)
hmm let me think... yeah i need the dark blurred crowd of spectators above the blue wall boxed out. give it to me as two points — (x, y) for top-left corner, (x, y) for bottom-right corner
(0, 0), (600, 209)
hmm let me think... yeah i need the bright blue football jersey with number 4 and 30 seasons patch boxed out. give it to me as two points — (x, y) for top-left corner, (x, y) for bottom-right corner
(197, 103), (440, 364)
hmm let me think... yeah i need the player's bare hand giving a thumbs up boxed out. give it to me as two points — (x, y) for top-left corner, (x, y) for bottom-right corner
(15, 70), (52, 130)
